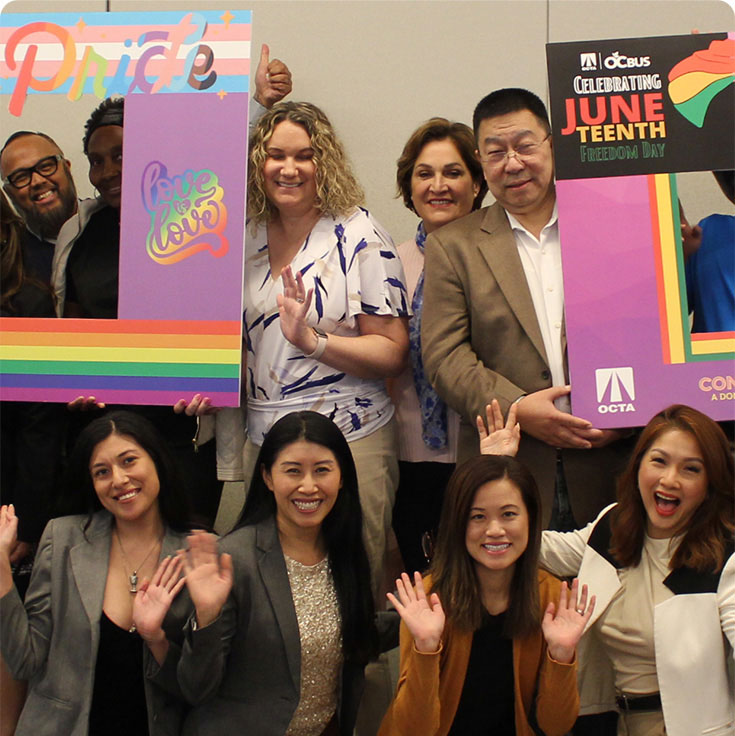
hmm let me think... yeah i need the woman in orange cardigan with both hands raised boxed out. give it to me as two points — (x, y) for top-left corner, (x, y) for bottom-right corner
(379, 455), (594, 736)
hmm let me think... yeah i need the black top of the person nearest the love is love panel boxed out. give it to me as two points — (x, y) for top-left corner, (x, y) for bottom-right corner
(66, 207), (120, 319)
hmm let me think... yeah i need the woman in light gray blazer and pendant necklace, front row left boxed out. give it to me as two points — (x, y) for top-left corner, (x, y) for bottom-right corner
(0, 411), (196, 736)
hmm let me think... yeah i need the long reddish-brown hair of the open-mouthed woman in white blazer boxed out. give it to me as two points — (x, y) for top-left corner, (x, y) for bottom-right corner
(610, 404), (735, 573)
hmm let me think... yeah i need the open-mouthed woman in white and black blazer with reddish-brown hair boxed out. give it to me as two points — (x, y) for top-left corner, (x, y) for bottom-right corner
(540, 405), (735, 736)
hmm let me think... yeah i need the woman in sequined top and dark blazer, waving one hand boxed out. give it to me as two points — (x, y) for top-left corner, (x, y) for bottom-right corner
(178, 411), (377, 736)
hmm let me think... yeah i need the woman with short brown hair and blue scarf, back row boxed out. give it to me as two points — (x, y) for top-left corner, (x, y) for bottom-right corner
(389, 118), (487, 570)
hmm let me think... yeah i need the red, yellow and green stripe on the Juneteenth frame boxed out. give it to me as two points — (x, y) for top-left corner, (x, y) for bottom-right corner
(647, 174), (735, 365)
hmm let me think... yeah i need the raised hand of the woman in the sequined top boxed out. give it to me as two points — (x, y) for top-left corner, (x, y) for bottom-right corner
(179, 531), (232, 627)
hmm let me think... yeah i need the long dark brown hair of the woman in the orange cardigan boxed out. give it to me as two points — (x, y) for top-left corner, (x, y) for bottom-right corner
(430, 455), (541, 638)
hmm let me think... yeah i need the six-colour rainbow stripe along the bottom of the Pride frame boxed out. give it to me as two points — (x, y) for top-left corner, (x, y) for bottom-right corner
(0, 317), (242, 406)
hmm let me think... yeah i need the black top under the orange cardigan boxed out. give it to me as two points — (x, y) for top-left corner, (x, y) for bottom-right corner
(449, 613), (516, 736)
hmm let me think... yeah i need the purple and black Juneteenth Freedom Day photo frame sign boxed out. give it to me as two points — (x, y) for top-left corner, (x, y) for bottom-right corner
(547, 33), (735, 427)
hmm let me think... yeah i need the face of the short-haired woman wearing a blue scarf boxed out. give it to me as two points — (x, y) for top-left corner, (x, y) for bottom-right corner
(411, 138), (480, 233)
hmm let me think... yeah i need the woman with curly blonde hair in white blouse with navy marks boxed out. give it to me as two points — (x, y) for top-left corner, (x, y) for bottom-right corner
(244, 102), (408, 588)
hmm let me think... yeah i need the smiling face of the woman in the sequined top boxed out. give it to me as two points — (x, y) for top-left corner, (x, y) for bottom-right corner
(262, 440), (342, 535)
